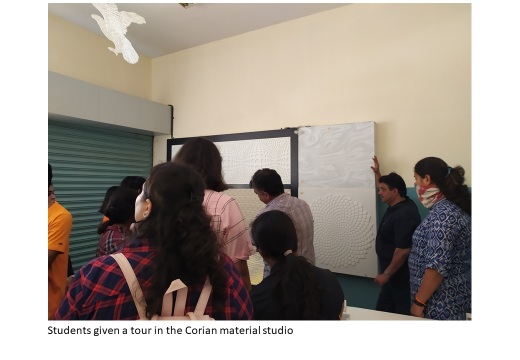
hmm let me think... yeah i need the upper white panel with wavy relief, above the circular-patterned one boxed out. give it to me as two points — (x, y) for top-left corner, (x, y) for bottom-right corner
(298, 122), (374, 188)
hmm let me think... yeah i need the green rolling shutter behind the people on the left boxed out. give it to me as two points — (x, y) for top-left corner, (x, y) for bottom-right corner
(48, 120), (153, 271)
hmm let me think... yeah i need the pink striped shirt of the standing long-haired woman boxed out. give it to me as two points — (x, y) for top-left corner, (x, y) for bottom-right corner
(203, 190), (255, 262)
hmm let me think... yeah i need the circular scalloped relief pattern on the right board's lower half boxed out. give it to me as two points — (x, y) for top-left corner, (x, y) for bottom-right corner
(310, 195), (374, 267)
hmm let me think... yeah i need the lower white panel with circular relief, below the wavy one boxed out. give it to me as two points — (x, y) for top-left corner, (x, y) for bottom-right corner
(298, 187), (377, 277)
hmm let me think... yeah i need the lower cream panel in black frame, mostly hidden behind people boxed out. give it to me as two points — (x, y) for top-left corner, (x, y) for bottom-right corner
(224, 189), (291, 285)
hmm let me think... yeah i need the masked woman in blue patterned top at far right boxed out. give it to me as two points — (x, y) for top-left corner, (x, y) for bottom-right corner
(408, 157), (471, 320)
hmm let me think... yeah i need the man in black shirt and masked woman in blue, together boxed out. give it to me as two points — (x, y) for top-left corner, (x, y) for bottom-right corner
(372, 157), (471, 320)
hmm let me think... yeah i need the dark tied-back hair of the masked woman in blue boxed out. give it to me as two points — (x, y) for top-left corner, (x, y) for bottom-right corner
(414, 157), (471, 215)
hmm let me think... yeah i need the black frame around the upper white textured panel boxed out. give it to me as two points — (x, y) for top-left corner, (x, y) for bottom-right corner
(166, 128), (298, 197)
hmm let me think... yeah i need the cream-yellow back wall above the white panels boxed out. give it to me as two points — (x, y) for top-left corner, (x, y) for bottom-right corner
(152, 4), (471, 186)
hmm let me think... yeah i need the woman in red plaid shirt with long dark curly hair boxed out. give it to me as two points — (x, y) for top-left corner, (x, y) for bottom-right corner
(55, 162), (253, 320)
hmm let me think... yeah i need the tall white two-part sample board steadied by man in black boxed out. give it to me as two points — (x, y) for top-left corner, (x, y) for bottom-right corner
(298, 122), (378, 277)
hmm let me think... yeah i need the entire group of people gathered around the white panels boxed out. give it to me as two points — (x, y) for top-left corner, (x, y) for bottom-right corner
(49, 138), (471, 320)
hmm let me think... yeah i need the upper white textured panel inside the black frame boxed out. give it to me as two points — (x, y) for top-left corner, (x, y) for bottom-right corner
(172, 137), (291, 184)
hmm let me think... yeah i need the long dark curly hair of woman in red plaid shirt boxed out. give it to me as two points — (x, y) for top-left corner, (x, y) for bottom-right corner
(136, 162), (227, 318)
